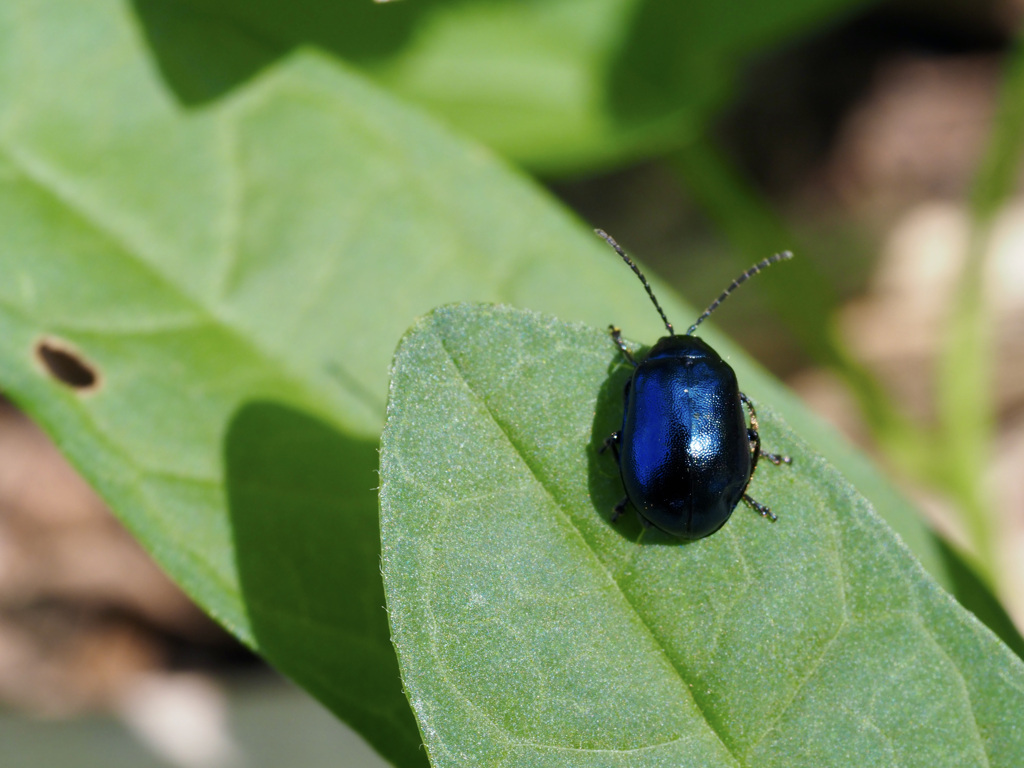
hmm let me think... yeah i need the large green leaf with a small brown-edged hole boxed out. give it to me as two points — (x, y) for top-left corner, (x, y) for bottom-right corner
(0, 0), (991, 765)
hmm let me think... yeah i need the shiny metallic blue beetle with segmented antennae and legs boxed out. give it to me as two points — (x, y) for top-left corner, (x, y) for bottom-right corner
(595, 229), (793, 540)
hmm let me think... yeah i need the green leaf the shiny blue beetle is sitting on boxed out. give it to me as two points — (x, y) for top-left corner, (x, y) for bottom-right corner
(381, 305), (1024, 768)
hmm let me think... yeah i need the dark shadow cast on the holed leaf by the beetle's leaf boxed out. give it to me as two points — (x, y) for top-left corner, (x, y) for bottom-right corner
(224, 401), (427, 766)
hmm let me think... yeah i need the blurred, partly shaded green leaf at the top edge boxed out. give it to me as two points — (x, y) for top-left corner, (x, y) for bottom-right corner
(134, 0), (865, 172)
